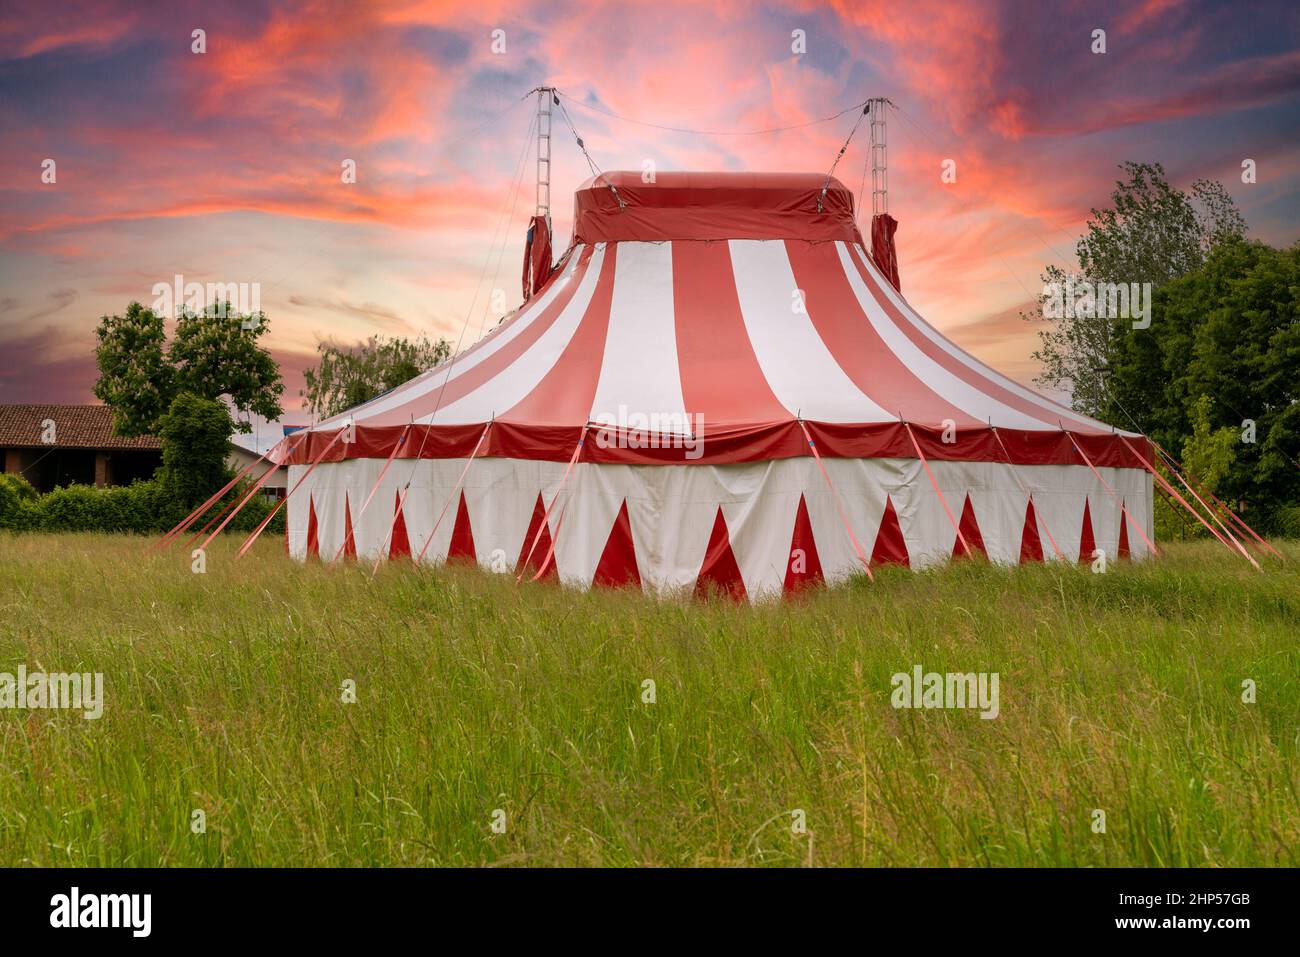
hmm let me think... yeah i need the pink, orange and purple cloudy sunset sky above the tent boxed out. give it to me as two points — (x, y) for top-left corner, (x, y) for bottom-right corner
(0, 0), (1300, 419)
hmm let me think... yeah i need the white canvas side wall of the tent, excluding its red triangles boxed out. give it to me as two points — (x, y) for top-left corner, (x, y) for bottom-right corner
(289, 458), (1152, 598)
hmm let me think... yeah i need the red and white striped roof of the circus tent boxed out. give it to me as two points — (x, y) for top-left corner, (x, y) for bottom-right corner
(293, 173), (1141, 467)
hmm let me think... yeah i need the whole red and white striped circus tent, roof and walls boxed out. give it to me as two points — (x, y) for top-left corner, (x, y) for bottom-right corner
(279, 167), (1152, 598)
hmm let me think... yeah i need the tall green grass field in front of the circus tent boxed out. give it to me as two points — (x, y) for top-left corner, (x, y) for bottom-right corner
(0, 534), (1300, 866)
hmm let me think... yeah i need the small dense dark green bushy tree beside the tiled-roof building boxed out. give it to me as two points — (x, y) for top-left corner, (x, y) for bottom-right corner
(156, 391), (235, 508)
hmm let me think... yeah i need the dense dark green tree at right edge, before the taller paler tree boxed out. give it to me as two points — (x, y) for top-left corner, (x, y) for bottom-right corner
(1105, 239), (1300, 532)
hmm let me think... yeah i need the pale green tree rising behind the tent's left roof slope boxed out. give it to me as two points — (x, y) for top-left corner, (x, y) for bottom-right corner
(300, 335), (451, 419)
